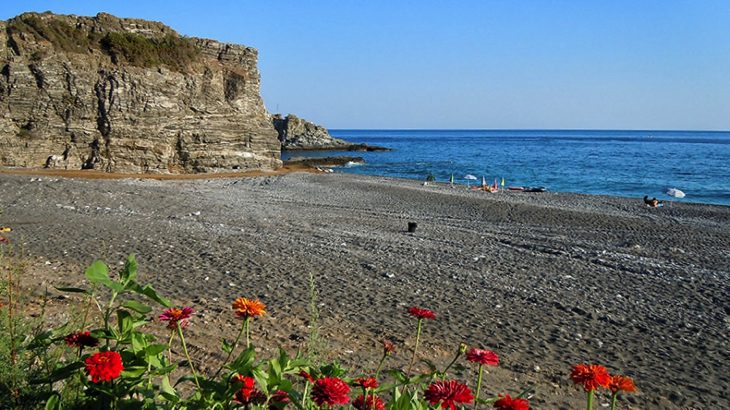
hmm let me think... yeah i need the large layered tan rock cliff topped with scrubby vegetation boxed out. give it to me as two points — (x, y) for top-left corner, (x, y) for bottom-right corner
(0, 13), (281, 173)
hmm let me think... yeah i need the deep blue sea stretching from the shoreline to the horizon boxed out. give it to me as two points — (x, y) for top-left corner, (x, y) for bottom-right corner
(282, 129), (730, 205)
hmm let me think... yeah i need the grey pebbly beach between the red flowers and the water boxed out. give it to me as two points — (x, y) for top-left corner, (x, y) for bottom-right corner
(0, 172), (730, 409)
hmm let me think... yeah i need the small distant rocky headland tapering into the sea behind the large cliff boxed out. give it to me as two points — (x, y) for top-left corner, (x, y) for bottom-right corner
(271, 114), (390, 151)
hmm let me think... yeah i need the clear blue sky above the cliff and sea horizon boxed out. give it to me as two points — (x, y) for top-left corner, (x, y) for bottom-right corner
(0, 0), (730, 130)
